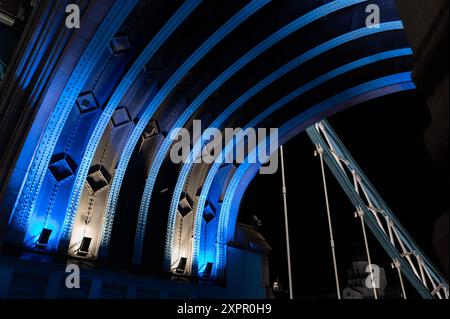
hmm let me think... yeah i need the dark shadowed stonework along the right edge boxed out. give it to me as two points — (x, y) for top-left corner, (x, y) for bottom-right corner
(396, 0), (450, 278)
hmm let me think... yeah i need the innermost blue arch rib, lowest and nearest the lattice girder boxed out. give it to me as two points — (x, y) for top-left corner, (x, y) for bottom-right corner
(214, 72), (415, 276)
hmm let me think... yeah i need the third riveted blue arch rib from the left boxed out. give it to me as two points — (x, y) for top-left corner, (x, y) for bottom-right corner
(91, 0), (270, 255)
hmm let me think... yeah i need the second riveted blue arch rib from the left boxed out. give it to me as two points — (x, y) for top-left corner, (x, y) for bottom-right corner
(62, 0), (201, 250)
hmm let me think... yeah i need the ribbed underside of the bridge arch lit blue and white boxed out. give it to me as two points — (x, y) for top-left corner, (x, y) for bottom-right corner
(0, 0), (446, 295)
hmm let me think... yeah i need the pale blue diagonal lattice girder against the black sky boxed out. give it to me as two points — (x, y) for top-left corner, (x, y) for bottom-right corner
(307, 121), (449, 299)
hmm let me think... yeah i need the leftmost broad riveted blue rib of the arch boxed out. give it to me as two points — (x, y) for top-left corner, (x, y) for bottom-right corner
(9, 0), (137, 241)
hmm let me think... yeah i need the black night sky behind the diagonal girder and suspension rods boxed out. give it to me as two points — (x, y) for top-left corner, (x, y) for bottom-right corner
(240, 92), (448, 298)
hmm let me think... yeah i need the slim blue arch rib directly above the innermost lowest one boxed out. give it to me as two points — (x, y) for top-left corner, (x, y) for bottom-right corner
(192, 48), (412, 276)
